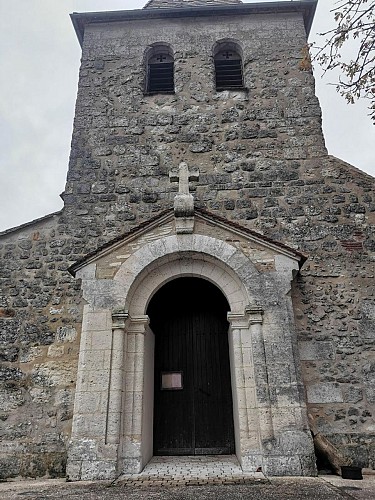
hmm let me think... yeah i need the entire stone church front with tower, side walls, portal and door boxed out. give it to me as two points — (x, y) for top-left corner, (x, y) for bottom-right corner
(0, 0), (375, 480)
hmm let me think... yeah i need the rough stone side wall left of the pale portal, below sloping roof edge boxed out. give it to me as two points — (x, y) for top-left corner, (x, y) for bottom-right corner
(0, 213), (82, 479)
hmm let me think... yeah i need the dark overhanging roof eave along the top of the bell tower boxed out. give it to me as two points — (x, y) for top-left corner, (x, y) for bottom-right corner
(70, 0), (318, 46)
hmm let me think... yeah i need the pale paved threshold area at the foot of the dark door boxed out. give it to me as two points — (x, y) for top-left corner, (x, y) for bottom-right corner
(115, 455), (266, 486)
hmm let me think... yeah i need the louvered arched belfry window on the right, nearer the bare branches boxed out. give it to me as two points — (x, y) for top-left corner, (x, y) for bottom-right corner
(215, 49), (243, 90)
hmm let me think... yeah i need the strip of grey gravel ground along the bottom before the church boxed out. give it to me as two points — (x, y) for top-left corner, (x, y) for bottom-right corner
(0, 476), (375, 500)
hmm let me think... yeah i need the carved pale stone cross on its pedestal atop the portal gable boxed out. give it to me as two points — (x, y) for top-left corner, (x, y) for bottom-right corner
(169, 162), (199, 234)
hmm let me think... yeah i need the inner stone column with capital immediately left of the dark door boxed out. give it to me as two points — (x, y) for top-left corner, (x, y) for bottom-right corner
(120, 316), (149, 474)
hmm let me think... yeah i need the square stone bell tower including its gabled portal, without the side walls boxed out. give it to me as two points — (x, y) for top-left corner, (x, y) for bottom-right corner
(64, 0), (320, 479)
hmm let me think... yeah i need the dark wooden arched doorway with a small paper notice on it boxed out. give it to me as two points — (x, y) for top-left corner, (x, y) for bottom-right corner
(147, 277), (234, 455)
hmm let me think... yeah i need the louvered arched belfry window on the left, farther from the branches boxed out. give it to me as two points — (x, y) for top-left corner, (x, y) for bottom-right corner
(147, 50), (174, 94)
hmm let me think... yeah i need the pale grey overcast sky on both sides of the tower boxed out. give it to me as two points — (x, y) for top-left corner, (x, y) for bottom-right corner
(0, 0), (375, 231)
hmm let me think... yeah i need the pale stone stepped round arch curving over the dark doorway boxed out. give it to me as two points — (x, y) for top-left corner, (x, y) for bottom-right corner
(114, 235), (262, 316)
